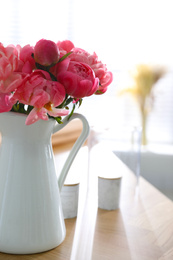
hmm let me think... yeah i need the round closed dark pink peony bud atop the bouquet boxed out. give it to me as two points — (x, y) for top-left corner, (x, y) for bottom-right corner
(34, 39), (60, 66)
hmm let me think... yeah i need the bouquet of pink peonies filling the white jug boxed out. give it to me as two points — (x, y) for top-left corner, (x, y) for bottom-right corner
(0, 39), (113, 125)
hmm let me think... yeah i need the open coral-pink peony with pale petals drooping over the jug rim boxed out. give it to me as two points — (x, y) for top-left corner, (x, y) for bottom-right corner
(13, 70), (68, 125)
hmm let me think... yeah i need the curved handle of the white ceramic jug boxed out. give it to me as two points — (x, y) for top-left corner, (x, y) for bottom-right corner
(53, 113), (90, 190)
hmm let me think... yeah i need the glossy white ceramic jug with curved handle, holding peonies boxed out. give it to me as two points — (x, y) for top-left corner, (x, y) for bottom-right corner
(0, 112), (89, 254)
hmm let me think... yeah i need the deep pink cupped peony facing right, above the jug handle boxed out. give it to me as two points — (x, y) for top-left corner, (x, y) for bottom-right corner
(57, 59), (99, 99)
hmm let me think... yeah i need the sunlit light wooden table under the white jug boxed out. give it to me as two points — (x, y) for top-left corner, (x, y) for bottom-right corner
(0, 146), (173, 260)
